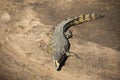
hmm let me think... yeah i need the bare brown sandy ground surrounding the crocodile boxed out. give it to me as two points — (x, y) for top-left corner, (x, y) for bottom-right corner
(0, 0), (120, 80)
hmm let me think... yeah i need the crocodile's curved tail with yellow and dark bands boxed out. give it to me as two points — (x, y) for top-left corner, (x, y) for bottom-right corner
(64, 13), (104, 32)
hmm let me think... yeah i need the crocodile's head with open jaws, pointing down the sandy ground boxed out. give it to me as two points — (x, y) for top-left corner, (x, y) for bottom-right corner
(54, 53), (67, 71)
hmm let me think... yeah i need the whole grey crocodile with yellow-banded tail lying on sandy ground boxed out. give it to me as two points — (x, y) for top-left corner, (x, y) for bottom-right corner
(47, 13), (103, 71)
